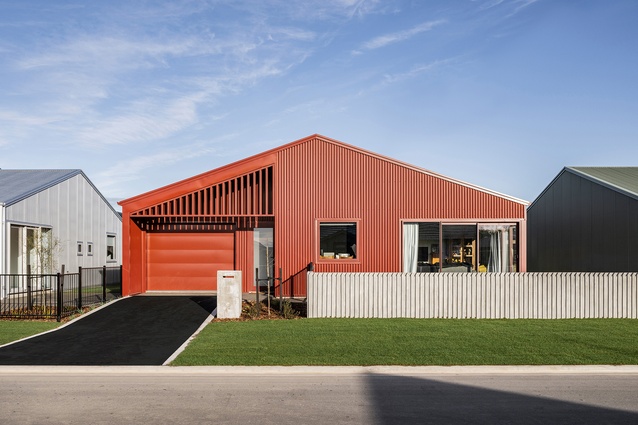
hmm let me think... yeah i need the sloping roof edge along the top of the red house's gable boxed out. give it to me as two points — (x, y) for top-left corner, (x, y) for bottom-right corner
(118, 134), (529, 210)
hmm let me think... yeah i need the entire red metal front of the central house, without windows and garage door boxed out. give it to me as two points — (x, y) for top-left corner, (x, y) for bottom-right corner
(120, 135), (526, 296)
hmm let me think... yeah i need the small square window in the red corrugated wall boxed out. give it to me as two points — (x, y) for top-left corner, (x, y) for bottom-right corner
(319, 222), (357, 260)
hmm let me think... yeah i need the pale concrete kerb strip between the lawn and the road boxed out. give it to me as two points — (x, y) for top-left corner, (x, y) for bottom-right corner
(0, 365), (638, 377)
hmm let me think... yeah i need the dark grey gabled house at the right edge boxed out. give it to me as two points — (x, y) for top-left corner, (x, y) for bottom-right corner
(527, 167), (638, 272)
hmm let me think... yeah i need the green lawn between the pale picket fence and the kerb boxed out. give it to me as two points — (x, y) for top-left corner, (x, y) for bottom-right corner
(172, 319), (638, 366)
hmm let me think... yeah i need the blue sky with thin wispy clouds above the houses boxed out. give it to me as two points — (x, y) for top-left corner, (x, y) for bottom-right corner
(0, 0), (638, 210)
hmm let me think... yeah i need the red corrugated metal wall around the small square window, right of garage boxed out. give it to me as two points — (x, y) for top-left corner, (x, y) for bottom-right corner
(275, 138), (526, 295)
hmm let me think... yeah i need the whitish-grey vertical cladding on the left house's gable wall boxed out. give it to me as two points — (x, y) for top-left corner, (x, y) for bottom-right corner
(0, 173), (122, 273)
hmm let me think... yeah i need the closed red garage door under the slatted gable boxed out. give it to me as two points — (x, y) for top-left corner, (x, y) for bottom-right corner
(146, 233), (235, 291)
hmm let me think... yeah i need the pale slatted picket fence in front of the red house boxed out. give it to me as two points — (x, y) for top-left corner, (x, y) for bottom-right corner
(307, 272), (638, 319)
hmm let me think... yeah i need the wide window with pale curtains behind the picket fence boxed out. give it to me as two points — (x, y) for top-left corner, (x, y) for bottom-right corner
(403, 222), (518, 273)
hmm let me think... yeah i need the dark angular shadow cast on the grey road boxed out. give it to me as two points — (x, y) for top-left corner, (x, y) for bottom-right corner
(366, 374), (638, 425)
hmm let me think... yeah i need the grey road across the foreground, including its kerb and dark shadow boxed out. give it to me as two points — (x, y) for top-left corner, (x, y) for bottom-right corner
(0, 366), (638, 425)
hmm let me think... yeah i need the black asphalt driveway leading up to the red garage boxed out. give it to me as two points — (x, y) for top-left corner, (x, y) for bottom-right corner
(0, 296), (217, 365)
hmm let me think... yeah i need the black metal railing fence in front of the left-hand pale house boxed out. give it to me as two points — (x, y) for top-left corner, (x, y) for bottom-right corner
(0, 266), (122, 322)
